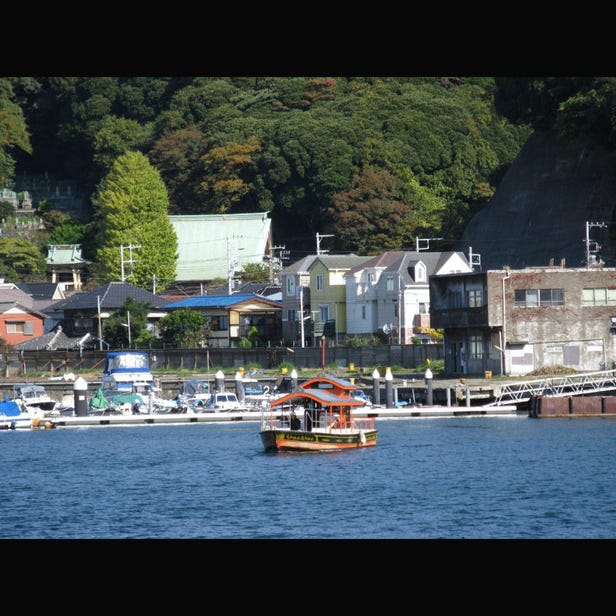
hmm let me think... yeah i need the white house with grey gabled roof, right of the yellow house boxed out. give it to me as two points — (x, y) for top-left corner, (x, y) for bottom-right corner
(344, 251), (472, 344)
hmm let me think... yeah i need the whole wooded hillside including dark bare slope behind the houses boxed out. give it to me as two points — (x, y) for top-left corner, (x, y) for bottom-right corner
(0, 76), (616, 286)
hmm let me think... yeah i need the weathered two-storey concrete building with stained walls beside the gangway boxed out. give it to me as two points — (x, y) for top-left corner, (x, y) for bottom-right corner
(430, 266), (616, 376)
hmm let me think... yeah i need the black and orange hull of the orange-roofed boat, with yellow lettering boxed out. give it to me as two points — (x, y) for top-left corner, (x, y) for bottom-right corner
(260, 428), (377, 451)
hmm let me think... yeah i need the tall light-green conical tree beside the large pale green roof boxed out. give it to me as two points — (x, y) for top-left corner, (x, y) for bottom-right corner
(93, 152), (177, 288)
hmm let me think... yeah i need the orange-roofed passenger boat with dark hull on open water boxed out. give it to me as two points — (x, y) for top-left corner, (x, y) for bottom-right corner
(260, 376), (377, 452)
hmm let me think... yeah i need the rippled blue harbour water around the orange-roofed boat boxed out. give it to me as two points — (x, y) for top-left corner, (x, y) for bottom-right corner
(0, 417), (616, 539)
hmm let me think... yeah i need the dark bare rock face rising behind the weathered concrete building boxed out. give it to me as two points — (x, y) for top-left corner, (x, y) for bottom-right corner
(456, 133), (616, 270)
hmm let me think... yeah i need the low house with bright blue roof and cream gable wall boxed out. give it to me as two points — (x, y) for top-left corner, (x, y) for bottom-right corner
(162, 293), (282, 348)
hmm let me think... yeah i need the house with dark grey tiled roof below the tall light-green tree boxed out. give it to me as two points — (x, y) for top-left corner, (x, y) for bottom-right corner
(50, 282), (167, 339)
